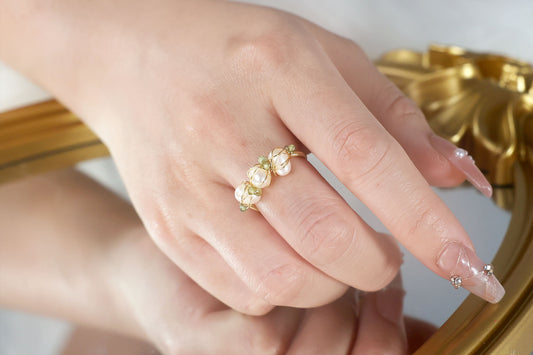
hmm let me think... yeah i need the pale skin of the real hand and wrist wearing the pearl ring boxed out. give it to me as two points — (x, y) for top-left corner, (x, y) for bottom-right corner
(0, 0), (488, 315)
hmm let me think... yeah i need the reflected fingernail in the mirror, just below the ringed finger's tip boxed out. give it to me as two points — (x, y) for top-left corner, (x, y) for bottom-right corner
(376, 273), (405, 324)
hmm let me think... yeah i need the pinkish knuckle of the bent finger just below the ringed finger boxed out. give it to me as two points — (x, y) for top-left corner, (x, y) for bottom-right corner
(257, 264), (305, 306)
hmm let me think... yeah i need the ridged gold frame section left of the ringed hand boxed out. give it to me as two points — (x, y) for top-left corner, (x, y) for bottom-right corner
(0, 100), (109, 183)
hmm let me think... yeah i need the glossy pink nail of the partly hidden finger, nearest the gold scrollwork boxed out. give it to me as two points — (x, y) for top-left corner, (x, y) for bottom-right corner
(429, 134), (492, 197)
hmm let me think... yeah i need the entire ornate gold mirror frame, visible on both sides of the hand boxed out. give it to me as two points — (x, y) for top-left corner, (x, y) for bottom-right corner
(0, 46), (533, 354)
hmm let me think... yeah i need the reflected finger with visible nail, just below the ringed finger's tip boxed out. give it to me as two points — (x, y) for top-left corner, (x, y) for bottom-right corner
(352, 274), (407, 355)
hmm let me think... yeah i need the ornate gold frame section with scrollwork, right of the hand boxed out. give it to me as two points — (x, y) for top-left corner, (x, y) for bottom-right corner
(377, 45), (533, 355)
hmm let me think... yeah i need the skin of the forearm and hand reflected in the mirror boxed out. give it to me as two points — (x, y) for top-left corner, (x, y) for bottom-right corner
(0, 171), (434, 354)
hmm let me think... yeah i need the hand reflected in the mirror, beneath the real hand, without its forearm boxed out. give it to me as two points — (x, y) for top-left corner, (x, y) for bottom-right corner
(109, 229), (435, 354)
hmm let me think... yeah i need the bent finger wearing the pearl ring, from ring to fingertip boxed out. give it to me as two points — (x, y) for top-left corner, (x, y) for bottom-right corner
(219, 146), (402, 292)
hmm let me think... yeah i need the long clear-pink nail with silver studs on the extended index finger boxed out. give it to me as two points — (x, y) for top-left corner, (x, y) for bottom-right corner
(437, 242), (505, 303)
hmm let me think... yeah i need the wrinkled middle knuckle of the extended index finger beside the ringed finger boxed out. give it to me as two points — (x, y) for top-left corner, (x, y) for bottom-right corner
(334, 122), (392, 182)
